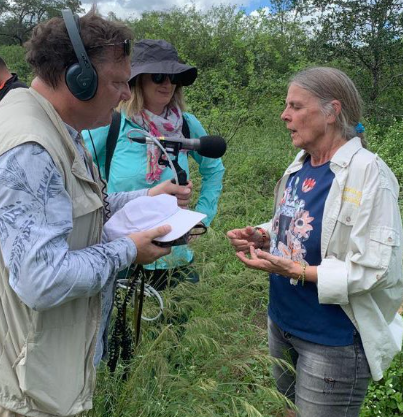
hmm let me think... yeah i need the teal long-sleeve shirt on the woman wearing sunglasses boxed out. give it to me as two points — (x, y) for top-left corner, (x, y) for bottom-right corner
(82, 112), (225, 269)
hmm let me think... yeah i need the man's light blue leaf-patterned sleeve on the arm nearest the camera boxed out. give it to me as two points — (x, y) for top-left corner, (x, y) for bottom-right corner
(0, 143), (137, 311)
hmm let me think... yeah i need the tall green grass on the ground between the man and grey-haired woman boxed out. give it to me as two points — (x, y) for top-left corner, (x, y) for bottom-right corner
(86, 113), (403, 417)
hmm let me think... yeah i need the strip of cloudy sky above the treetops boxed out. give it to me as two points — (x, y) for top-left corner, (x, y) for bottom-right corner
(81, 0), (270, 19)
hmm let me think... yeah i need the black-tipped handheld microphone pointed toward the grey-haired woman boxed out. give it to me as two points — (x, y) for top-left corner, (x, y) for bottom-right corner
(129, 136), (227, 158)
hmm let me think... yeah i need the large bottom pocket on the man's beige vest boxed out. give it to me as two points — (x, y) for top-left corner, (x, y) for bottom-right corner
(14, 324), (85, 415)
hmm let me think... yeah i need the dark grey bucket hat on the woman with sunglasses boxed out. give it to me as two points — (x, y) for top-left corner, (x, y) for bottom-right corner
(129, 39), (197, 85)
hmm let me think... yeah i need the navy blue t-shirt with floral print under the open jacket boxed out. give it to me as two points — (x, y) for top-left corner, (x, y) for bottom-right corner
(269, 157), (354, 346)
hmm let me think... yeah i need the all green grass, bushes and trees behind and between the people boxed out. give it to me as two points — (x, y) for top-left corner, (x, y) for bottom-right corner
(0, 0), (403, 417)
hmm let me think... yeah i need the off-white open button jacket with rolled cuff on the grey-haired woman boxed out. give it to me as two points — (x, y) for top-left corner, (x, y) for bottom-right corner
(260, 137), (403, 381)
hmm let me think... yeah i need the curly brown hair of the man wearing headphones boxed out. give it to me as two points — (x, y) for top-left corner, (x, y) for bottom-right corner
(25, 7), (133, 88)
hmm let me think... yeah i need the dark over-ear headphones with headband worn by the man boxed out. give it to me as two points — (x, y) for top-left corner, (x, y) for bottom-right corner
(62, 9), (98, 101)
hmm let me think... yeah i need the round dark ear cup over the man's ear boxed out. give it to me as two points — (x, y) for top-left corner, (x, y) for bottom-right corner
(65, 64), (98, 101)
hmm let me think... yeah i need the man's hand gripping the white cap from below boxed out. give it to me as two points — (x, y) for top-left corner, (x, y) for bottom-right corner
(128, 225), (171, 264)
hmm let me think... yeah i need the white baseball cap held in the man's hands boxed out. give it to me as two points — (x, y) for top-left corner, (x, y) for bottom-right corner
(104, 194), (206, 242)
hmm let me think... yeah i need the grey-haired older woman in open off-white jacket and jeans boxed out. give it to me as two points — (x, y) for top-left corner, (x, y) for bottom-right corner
(227, 67), (403, 417)
